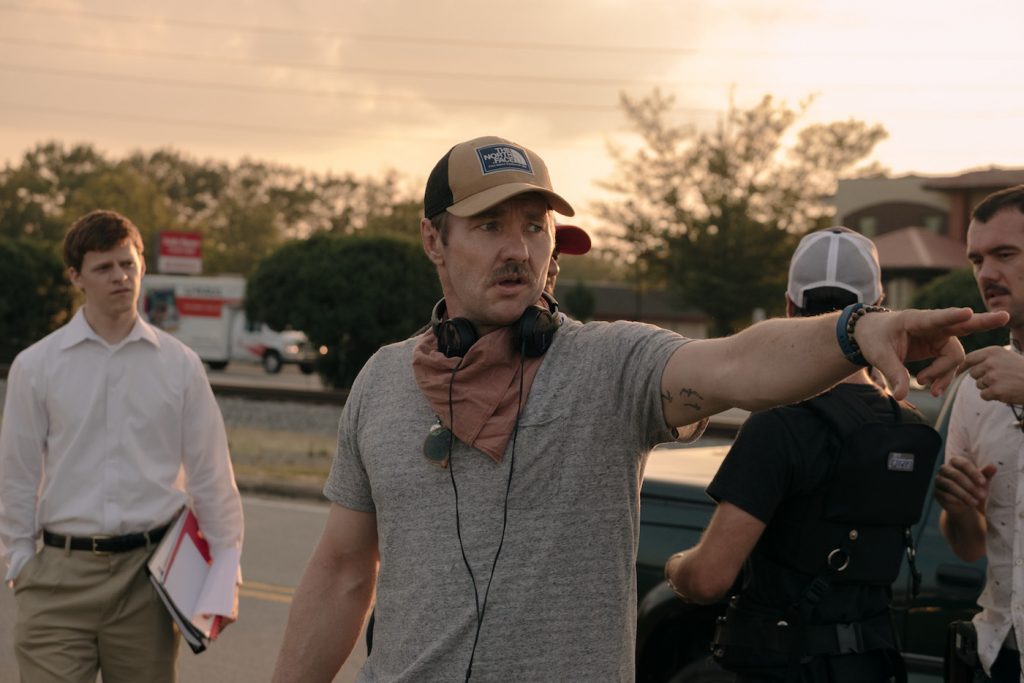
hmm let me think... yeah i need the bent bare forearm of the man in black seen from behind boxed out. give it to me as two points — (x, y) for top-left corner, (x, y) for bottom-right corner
(665, 501), (765, 604)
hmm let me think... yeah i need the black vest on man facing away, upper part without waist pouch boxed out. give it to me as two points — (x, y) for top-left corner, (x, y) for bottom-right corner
(761, 391), (942, 586)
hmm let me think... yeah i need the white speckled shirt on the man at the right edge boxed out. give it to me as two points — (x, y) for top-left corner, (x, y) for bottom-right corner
(946, 358), (1024, 672)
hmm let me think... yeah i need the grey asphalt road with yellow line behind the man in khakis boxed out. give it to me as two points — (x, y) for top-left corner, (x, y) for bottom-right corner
(0, 496), (366, 683)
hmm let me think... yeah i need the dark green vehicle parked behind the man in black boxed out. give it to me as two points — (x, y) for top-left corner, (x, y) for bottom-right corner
(636, 391), (985, 683)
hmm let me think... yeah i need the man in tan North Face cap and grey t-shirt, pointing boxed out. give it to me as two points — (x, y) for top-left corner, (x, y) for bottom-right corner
(274, 137), (1005, 682)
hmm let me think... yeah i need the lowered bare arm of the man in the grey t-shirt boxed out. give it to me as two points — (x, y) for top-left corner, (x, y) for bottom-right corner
(273, 505), (378, 683)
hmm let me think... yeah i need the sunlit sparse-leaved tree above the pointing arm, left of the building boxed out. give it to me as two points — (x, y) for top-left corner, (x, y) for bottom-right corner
(596, 90), (886, 335)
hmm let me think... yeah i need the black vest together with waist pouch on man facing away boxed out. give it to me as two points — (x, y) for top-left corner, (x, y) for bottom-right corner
(714, 390), (942, 680)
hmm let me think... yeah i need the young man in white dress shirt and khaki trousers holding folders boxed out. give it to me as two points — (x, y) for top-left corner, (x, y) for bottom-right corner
(0, 211), (243, 683)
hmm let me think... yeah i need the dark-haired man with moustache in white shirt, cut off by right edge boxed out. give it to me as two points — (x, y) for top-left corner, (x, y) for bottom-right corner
(935, 185), (1024, 683)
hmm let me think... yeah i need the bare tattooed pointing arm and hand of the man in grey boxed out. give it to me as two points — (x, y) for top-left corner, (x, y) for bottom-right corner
(662, 308), (1008, 427)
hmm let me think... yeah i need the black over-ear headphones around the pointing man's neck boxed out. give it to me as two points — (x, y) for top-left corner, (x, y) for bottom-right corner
(430, 292), (560, 358)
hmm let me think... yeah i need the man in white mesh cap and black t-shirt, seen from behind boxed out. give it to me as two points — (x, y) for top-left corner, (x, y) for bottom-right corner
(666, 227), (941, 683)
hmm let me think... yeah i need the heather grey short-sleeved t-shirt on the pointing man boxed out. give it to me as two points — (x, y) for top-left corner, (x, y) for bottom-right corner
(324, 321), (686, 683)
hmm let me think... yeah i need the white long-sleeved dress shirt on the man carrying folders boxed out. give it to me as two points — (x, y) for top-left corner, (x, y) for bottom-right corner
(0, 309), (243, 580)
